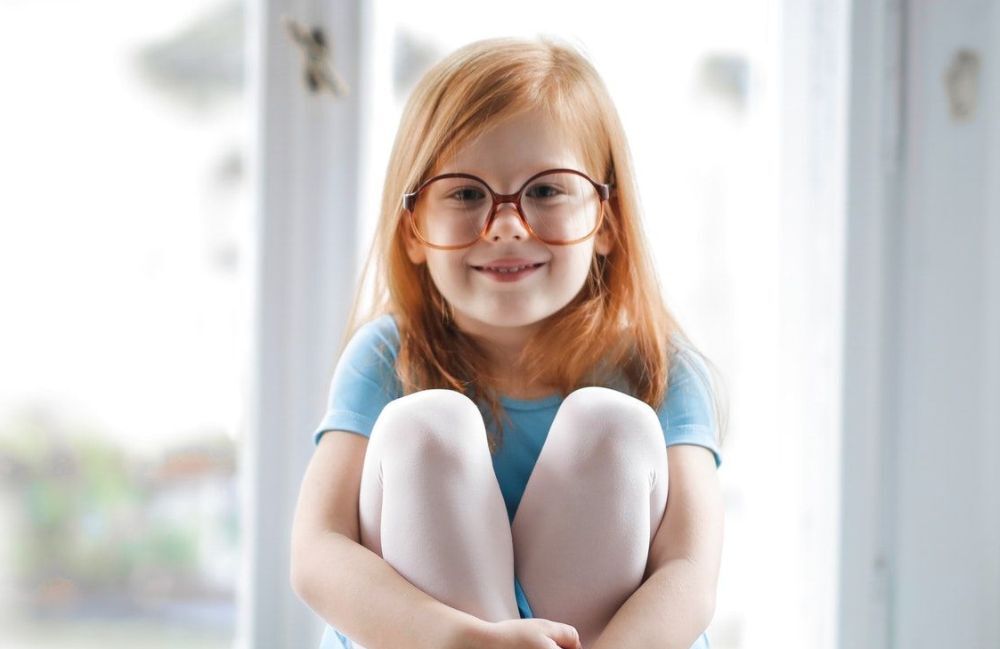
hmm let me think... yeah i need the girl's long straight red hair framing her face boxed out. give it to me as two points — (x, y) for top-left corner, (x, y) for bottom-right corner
(344, 38), (719, 450)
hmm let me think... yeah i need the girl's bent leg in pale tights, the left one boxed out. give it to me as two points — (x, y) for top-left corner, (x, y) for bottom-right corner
(359, 390), (519, 622)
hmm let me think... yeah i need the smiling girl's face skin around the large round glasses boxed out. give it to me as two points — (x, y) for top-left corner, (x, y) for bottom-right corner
(404, 111), (611, 344)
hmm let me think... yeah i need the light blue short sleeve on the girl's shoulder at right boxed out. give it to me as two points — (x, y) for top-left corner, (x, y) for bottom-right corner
(656, 347), (722, 468)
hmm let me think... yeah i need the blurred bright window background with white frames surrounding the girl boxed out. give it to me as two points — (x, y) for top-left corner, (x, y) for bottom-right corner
(0, 0), (1000, 649)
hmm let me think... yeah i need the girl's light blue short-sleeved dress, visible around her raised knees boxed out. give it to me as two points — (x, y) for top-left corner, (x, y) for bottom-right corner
(313, 315), (722, 649)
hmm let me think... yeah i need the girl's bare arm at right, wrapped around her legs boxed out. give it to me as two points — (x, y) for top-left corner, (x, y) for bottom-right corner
(585, 444), (725, 649)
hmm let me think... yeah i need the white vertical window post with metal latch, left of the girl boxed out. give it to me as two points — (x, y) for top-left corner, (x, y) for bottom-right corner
(237, 0), (370, 649)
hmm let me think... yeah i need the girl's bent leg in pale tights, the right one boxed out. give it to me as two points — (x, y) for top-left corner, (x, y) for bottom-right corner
(512, 387), (668, 647)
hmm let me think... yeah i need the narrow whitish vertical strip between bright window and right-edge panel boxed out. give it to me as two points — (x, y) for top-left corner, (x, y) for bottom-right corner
(838, 0), (903, 649)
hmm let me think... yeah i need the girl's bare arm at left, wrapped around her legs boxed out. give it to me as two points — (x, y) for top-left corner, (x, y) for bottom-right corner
(291, 431), (487, 649)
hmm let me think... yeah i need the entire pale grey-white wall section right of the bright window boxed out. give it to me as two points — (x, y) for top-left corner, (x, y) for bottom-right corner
(841, 0), (1000, 648)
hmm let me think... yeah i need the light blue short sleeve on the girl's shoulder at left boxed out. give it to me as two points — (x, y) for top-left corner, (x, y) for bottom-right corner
(313, 315), (402, 444)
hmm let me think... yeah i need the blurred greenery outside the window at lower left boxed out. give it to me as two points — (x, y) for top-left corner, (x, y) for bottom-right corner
(0, 408), (238, 608)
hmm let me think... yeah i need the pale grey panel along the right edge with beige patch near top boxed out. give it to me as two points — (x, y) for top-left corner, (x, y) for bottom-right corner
(889, 0), (1000, 648)
